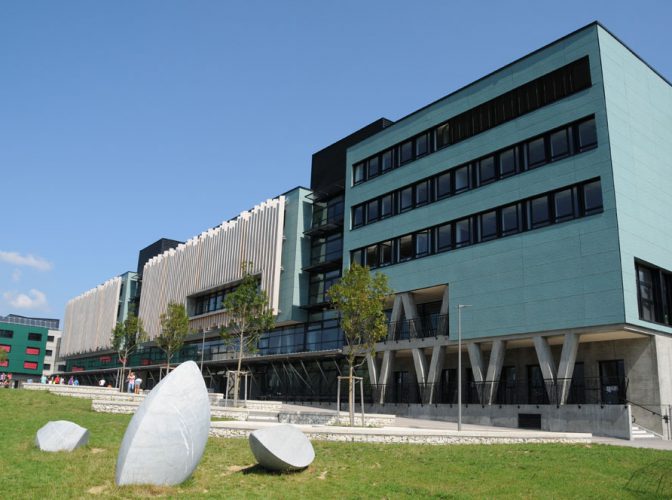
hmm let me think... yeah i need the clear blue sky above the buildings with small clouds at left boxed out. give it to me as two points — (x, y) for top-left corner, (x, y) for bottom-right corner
(0, 0), (672, 318)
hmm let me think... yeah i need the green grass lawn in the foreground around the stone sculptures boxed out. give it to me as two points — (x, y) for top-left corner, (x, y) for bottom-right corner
(0, 389), (672, 499)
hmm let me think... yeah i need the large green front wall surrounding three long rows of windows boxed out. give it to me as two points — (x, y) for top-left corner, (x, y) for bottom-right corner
(344, 25), (624, 338)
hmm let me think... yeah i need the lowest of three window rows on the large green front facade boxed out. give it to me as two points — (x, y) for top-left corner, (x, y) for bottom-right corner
(351, 179), (602, 268)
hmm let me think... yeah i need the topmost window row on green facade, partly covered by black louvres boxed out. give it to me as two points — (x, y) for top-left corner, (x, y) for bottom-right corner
(352, 56), (592, 184)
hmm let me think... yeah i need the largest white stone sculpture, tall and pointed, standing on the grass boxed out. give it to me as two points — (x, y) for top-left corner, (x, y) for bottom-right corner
(115, 361), (210, 485)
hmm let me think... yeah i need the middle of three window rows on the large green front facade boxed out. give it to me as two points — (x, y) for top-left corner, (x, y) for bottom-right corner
(351, 117), (597, 229)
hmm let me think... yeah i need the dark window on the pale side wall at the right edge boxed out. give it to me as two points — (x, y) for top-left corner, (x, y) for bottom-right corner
(635, 262), (672, 326)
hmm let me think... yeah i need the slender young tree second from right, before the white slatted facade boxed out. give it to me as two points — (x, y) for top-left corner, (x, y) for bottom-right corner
(221, 262), (274, 406)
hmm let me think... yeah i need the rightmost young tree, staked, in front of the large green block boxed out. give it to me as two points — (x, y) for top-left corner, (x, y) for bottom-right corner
(328, 264), (392, 425)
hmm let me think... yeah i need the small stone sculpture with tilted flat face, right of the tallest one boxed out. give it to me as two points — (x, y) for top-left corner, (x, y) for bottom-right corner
(250, 424), (315, 472)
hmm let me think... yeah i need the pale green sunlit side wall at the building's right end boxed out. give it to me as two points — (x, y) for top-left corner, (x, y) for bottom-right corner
(599, 28), (672, 333)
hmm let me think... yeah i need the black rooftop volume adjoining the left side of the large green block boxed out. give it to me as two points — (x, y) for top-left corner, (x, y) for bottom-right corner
(310, 118), (393, 197)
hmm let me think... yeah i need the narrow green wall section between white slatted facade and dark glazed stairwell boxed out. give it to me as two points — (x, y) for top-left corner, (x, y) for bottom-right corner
(276, 187), (312, 323)
